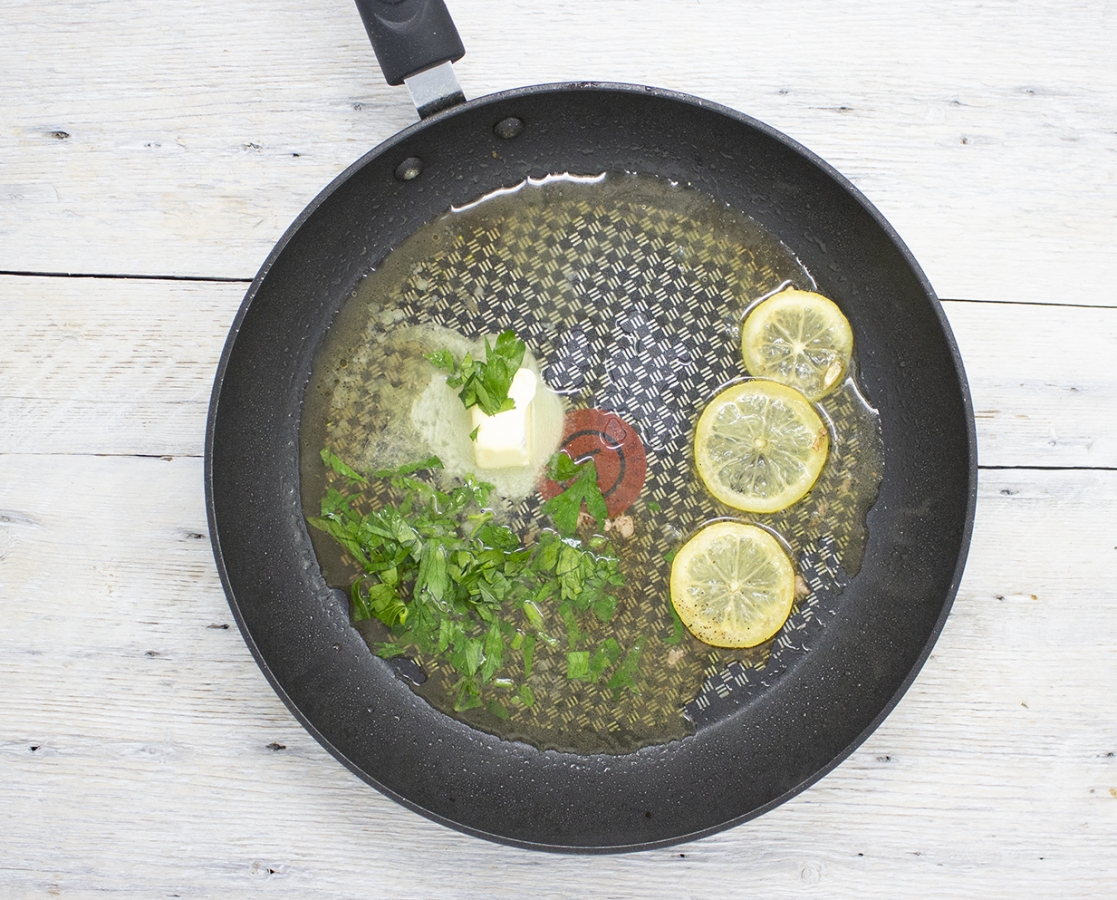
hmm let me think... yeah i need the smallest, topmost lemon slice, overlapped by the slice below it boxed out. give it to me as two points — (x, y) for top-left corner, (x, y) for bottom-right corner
(741, 290), (853, 400)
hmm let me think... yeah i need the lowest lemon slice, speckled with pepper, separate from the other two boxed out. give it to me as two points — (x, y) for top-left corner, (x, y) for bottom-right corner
(671, 521), (795, 648)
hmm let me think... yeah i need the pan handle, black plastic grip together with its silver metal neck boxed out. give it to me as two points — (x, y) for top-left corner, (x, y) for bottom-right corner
(355, 0), (466, 118)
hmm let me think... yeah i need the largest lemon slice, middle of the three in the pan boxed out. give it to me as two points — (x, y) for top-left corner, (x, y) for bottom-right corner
(695, 379), (830, 513)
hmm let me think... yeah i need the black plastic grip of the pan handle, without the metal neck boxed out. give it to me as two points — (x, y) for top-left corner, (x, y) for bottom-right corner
(356, 0), (466, 85)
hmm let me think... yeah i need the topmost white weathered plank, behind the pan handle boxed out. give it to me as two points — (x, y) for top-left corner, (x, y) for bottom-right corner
(0, 0), (1117, 304)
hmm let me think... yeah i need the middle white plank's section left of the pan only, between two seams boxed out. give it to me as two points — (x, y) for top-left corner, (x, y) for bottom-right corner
(0, 276), (246, 456)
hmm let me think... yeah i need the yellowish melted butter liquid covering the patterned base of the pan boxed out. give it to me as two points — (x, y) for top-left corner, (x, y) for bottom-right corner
(300, 174), (884, 754)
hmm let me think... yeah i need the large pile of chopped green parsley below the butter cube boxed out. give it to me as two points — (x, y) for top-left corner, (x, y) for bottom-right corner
(308, 449), (639, 718)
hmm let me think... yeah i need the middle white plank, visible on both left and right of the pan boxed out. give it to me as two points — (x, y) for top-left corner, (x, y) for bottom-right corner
(0, 276), (1117, 467)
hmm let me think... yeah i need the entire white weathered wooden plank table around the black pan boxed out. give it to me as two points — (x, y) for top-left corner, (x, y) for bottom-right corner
(0, 0), (1117, 900)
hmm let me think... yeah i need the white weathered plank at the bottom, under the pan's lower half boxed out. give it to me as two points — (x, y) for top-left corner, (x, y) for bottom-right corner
(0, 456), (1117, 898)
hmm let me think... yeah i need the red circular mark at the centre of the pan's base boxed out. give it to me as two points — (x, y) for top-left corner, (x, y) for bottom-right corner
(540, 410), (648, 516)
